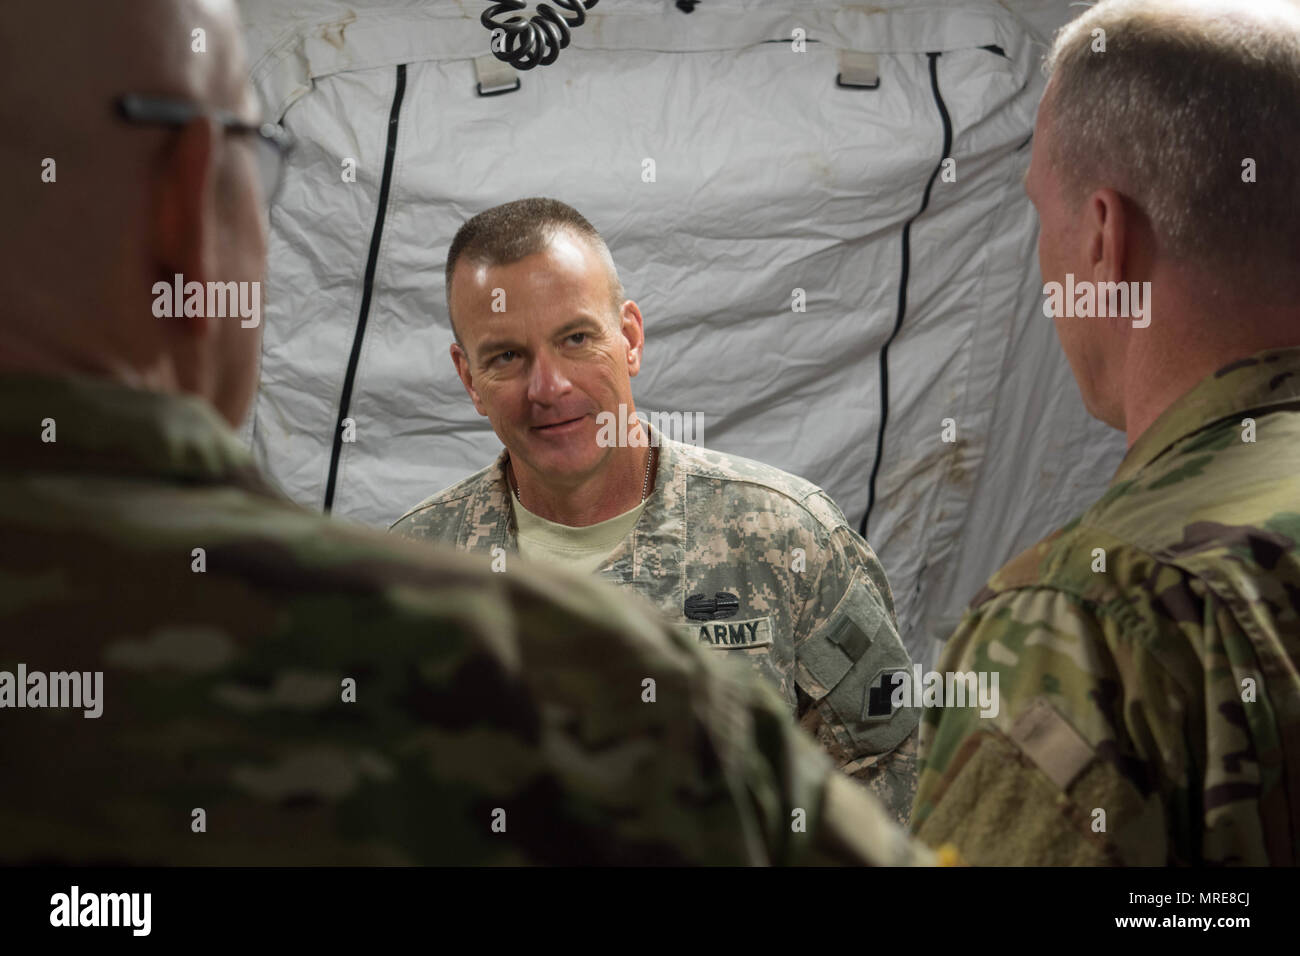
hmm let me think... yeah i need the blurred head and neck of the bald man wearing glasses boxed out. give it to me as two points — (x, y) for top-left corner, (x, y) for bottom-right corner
(0, 3), (285, 421)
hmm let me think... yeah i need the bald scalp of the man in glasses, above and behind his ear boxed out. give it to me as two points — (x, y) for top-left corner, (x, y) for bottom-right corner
(0, 0), (248, 329)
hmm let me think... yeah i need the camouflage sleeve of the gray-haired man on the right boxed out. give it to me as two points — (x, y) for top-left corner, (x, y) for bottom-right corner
(913, 531), (1284, 865)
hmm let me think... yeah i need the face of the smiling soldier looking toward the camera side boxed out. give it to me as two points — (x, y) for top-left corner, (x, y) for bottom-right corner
(451, 233), (644, 485)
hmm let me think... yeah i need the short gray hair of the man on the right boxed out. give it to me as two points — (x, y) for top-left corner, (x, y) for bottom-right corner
(1045, 0), (1300, 299)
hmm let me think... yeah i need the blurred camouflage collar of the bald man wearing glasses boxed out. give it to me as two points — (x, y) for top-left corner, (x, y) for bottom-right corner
(0, 373), (270, 492)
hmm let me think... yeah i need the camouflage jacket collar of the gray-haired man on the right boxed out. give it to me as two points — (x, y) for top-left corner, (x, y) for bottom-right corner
(1112, 349), (1300, 484)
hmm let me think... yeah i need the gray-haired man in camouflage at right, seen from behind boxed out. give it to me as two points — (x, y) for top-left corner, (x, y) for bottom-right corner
(914, 0), (1300, 865)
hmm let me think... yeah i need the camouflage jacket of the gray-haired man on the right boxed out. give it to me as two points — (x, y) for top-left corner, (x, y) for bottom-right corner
(914, 350), (1300, 865)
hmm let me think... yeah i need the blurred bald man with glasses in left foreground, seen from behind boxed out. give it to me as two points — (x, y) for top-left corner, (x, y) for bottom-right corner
(0, 0), (928, 864)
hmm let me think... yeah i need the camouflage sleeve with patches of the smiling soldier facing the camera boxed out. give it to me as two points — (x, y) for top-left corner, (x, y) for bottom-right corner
(796, 493), (919, 825)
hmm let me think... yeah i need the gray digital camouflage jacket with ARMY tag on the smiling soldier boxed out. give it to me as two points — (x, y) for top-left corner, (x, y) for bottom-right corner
(393, 437), (919, 823)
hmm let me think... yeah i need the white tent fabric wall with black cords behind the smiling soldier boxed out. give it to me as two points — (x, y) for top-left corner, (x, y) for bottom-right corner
(236, 0), (1123, 666)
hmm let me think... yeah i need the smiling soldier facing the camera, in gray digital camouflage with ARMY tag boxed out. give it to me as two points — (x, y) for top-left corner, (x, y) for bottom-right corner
(393, 199), (919, 822)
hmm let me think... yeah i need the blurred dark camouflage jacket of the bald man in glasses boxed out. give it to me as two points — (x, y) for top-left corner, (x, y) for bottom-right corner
(0, 376), (930, 864)
